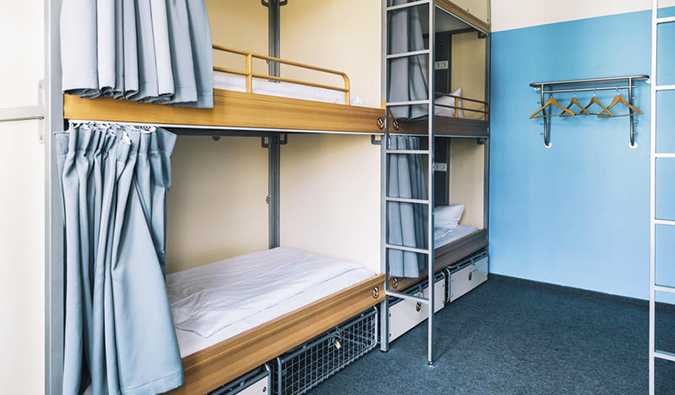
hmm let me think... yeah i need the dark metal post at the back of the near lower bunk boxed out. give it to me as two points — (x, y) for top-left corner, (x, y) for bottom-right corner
(267, 133), (281, 248)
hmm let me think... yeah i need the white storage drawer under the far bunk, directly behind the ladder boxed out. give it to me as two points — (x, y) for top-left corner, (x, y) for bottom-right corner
(389, 273), (445, 341)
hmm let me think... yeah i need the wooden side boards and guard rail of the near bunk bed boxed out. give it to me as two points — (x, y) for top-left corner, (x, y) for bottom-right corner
(63, 45), (385, 395)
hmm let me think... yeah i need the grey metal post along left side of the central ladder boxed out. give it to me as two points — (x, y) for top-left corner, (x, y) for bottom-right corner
(380, 0), (390, 352)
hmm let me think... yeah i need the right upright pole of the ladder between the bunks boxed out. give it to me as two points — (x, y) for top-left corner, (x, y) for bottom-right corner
(427, 0), (438, 366)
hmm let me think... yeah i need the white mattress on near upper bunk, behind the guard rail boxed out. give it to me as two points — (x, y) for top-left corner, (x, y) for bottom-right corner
(213, 72), (363, 106)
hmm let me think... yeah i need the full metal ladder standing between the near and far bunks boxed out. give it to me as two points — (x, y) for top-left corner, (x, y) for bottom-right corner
(380, 0), (436, 366)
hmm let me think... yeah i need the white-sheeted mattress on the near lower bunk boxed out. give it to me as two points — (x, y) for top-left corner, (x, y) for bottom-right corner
(167, 247), (375, 357)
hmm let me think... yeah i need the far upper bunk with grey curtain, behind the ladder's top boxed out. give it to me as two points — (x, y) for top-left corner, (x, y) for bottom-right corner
(387, 0), (490, 138)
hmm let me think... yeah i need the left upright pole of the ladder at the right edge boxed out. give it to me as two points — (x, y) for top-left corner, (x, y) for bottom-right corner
(649, 0), (659, 395)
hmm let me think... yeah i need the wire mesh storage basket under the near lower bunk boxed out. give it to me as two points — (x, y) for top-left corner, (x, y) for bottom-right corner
(272, 307), (378, 395)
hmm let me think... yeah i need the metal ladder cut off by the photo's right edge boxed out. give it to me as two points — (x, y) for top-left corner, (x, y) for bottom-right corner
(649, 0), (675, 395)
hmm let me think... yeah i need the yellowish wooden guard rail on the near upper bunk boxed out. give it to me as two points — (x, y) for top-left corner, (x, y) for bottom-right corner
(213, 44), (351, 106)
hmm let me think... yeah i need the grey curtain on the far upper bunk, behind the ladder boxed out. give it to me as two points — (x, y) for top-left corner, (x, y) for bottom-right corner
(387, 0), (428, 119)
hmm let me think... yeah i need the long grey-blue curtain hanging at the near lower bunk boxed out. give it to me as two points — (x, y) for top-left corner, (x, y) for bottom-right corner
(56, 123), (183, 395)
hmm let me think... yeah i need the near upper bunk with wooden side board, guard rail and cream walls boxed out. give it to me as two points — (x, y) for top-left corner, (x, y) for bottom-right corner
(64, 0), (384, 134)
